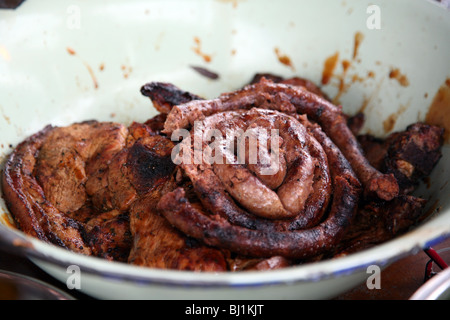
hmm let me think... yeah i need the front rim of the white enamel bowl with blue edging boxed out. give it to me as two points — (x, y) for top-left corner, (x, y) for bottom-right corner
(0, 219), (450, 288)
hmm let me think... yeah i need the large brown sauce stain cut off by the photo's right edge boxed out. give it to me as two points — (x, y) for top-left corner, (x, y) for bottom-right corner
(425, 78), (450, 143)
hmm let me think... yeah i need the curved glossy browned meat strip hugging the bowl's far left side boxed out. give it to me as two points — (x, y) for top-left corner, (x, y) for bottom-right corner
(2, 126), (91, 255)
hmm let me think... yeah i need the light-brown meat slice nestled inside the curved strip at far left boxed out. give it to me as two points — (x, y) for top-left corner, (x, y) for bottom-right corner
(35, 122), (128, 213)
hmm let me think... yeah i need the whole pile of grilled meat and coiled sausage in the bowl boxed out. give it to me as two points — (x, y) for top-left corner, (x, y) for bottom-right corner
(2, 74), (443, 271)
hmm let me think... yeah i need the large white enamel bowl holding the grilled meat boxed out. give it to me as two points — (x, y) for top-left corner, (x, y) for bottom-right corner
(0, 0), (450, 299)
